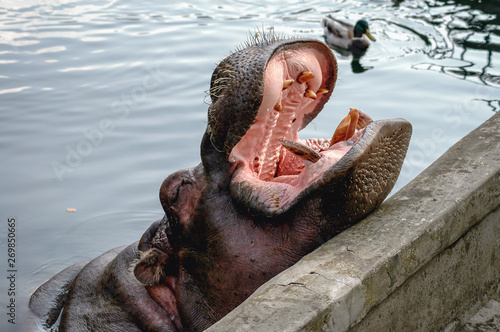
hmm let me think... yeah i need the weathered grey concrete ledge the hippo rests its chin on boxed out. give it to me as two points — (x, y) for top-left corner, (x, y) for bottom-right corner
(208, 114), (500, 331)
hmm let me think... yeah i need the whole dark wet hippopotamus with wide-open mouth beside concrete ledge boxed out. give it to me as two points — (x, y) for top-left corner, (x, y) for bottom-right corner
(30, 36), (411, 331)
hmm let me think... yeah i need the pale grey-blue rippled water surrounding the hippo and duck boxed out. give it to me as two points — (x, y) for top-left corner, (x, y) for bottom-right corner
(0, 0), (500, 331)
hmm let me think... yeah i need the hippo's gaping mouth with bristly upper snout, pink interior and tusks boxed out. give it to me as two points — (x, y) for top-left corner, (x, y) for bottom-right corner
(209, 40), (411, 217)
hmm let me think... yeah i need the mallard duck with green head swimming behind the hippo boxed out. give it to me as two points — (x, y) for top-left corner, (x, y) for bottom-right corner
(321, 15), (376, 53)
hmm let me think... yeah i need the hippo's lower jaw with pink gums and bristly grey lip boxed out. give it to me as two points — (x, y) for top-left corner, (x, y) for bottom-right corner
(230, 113), (411, 216)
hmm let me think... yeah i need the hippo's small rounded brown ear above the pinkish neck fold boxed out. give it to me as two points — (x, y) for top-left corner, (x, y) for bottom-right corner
(134, 249), (168, 286)
